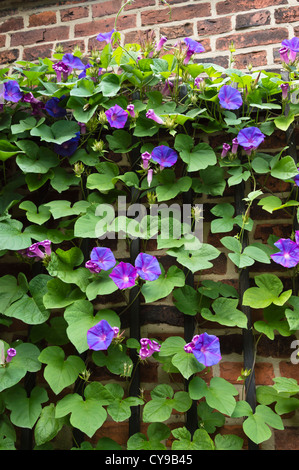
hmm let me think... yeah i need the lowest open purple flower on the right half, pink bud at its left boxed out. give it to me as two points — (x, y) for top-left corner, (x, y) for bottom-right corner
(184, 333), (221, 367)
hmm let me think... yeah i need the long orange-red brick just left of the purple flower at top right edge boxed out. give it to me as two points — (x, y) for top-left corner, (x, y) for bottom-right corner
(216, 28), (289, 51)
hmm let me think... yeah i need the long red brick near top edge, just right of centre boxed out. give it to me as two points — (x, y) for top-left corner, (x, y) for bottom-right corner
(141, 3), (211, 26)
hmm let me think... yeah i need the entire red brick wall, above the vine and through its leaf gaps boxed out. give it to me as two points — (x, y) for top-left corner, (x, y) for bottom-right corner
(0, 0), (299, 450)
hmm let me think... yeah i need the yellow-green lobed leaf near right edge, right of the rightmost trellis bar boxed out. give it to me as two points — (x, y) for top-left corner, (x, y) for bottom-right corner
(243, 274), (292, 308)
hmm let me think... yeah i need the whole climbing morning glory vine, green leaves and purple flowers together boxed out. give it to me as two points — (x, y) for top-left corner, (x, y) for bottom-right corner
(0, 2), (299, 450)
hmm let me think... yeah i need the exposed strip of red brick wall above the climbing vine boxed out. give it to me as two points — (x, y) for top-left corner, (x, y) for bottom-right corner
(0, 0), (299, 68)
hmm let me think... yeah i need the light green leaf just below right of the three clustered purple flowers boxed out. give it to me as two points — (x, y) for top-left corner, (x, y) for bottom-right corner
(141, 266), (185, 303)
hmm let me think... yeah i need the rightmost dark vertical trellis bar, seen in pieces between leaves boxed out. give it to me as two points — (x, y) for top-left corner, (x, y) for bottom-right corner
(235, 181), (258, 450)
